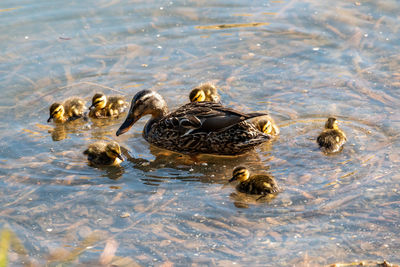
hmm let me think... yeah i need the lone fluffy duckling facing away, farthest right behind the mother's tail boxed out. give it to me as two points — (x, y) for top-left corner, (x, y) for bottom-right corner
(317, 117), (347, 154)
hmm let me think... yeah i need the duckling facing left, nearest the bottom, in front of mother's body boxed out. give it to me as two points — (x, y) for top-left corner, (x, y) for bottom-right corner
(229, 166), (279, 195)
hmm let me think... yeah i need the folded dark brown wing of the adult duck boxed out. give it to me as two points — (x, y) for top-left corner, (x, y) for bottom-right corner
(167, 102), (267, 133)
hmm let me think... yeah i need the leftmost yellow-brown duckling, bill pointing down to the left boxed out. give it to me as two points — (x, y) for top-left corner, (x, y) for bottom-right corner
(47, 97), (86, 123)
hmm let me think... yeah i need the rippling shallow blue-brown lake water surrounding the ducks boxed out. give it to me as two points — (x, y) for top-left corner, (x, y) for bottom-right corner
(0, 0), (400, 267)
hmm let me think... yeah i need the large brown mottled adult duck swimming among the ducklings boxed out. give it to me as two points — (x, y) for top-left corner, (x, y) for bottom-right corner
(116, 90), (271, 155)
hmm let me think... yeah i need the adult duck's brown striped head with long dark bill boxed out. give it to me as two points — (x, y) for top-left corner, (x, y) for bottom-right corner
(116, 90), (168, 136)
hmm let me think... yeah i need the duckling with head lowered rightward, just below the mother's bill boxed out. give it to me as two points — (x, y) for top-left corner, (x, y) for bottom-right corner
(83, 141), (124, 166)
